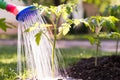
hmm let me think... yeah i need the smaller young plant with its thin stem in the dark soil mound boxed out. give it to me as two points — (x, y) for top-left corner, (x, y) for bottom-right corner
(86, 16), (118, 66)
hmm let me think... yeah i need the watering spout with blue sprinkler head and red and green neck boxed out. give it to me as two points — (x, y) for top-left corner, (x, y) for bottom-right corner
(0, 0), (36, 21)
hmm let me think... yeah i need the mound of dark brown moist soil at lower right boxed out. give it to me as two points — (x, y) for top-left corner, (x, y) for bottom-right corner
(67, 56), (120, 80)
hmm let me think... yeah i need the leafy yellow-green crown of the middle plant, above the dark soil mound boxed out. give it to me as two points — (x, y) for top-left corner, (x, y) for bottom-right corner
(86, 16), (119, 33)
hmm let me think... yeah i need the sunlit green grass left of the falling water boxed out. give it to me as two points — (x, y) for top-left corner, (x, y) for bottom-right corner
(0, 46), (17, 80)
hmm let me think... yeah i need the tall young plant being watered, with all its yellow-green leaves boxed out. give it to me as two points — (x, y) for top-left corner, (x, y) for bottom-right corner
(26, 3), (88, 76)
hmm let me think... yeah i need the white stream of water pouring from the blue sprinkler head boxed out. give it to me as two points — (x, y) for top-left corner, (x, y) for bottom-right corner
(17, 11), (66, 80)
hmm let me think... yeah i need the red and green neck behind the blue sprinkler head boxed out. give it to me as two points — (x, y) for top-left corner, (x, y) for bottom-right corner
(0, 0), (19, 15)
